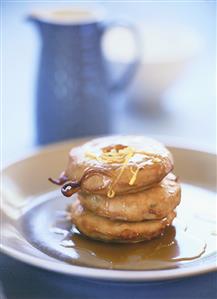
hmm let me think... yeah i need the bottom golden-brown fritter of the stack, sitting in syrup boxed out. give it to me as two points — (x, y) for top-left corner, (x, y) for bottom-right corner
(70, 199), (176, 243)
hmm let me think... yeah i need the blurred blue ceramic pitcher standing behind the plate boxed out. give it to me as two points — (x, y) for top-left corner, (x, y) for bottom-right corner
(30, 8), (141, 144)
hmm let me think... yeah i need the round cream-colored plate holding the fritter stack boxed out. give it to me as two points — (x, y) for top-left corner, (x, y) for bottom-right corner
(1, 140), (217, 281)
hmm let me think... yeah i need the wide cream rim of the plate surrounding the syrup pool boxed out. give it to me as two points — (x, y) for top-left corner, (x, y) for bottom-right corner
(1, 140), (217, 281)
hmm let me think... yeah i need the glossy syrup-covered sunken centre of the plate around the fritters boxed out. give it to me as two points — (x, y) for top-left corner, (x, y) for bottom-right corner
(20, 184), (216, 270)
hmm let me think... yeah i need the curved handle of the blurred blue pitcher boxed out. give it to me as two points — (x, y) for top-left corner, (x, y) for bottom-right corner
(102, 21), (141, 92)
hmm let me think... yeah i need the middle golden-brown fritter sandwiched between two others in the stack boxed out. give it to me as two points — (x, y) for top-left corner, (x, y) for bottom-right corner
(78, 173), (181, 221)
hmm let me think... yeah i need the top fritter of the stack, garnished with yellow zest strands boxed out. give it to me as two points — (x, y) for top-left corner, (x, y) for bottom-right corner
(51, 136), (173, 198)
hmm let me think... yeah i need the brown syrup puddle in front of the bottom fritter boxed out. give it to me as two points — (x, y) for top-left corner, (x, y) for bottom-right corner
(50, 226), (206, 270)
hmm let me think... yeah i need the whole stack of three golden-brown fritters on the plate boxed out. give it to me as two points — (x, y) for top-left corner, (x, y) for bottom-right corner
(51, 136), (181, 242)
